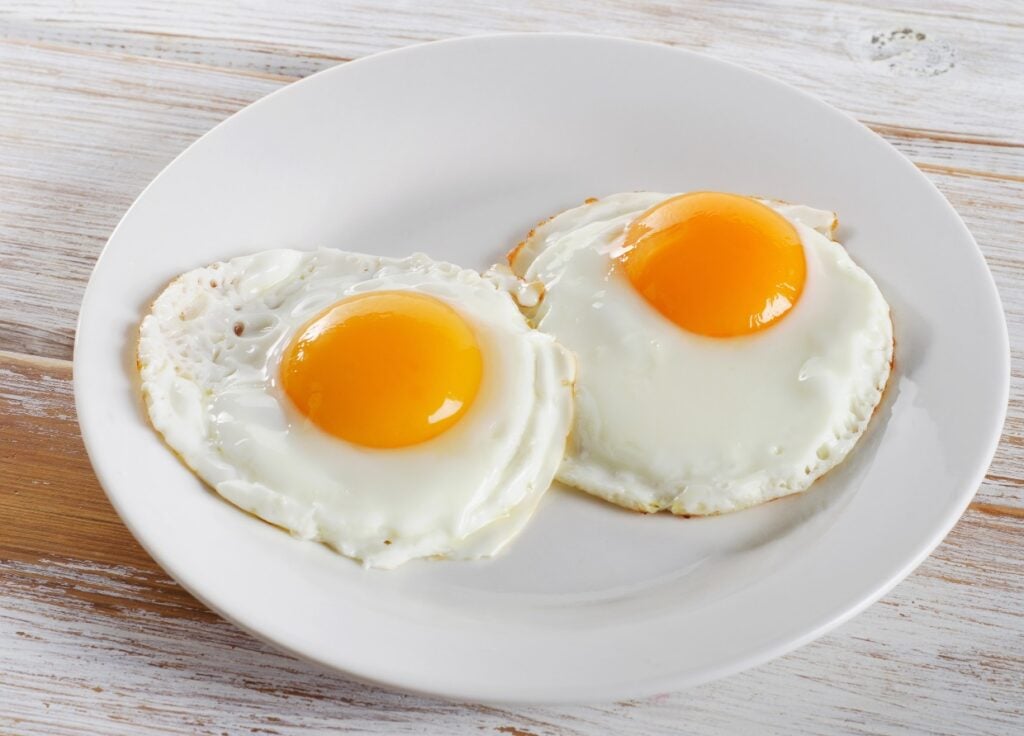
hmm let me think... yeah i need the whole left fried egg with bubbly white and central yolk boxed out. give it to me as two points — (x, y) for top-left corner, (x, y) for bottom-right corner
(138, 250), (574, 567)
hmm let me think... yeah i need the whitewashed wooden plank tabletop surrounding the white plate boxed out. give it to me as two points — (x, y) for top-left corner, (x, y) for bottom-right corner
(0, 0), (1024, 736)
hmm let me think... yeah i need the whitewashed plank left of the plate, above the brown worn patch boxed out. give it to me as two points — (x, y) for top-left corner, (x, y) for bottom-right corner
(0, 43), (281, 357)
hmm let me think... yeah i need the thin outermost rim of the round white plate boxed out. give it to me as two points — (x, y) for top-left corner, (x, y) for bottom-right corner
(73, 32), (1012, 704)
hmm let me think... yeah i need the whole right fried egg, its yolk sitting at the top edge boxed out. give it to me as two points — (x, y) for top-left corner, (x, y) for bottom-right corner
(509, 191), (893, 515)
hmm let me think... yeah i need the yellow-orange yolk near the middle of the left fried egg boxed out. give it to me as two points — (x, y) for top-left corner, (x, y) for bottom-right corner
(281, 292), (483, 448)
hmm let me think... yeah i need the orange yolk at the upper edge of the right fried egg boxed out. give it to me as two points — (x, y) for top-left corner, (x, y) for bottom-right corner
(621, 191), (806, 337)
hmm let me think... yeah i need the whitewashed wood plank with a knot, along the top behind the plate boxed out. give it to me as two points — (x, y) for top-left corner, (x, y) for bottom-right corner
(0, 0), (1024, 142)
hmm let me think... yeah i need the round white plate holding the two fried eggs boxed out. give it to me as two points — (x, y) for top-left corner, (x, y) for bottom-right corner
(75, 35), (1009, 701)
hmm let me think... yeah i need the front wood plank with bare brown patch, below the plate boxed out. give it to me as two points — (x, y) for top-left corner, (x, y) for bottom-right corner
(0, 355), (1024, 736)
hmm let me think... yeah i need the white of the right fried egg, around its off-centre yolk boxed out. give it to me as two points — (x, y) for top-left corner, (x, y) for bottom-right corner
(510, 192), (893, 515)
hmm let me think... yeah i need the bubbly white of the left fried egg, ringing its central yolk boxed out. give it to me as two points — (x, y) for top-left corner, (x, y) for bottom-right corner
(138, 250), (574, 567)
